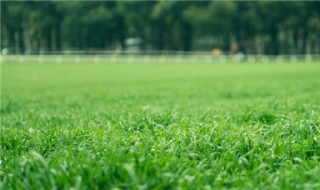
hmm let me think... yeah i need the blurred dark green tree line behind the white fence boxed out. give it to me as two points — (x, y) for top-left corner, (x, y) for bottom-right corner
(1, 1), (320, 55)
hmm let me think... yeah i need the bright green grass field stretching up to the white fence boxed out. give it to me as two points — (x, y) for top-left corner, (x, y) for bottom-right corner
(0, 60), (320, 189)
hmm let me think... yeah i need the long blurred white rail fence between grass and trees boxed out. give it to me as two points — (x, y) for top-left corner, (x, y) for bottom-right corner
(0, 52), (320, 64)
